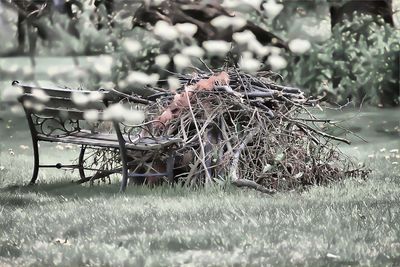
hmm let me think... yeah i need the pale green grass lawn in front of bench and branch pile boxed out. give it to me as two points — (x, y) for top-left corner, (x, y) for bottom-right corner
(0, 114), (400, 266)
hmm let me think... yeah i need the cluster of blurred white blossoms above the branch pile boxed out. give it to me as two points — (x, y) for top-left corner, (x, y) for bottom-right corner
(112, 0), (287, 95)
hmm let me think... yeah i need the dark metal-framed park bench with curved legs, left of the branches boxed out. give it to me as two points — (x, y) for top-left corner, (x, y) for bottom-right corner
(12, 81), (181, 192)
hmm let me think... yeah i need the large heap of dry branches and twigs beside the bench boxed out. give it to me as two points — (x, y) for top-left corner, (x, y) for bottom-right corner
(140, 68), (364, 193)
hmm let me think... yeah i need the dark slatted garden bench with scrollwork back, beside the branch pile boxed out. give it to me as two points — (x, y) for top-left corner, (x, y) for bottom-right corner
(12, 81), (181, 192)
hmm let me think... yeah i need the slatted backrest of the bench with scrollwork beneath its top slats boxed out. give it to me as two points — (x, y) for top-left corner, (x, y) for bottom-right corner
(12, 81), (123, 136)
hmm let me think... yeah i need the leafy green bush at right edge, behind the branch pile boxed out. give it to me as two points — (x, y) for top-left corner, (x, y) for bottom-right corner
(284, 14), (400, 105)
